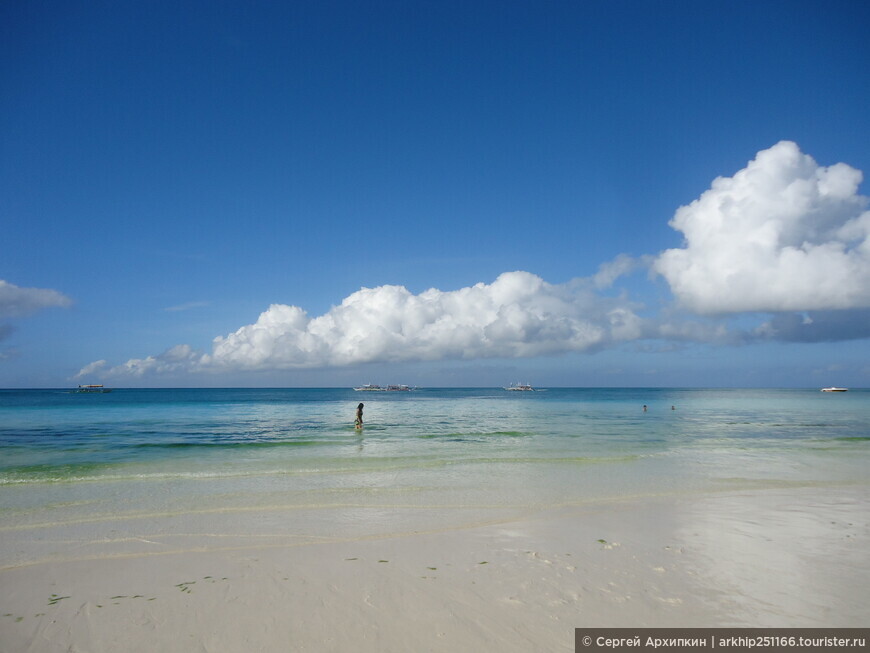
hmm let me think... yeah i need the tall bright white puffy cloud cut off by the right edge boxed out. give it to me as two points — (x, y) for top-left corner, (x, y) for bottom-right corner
(654, 141), (870, 314)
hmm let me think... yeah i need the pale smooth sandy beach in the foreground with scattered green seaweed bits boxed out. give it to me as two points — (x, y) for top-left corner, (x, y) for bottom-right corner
(0, 486), (870, 653)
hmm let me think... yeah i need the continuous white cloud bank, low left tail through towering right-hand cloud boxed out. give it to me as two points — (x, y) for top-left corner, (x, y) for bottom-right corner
(75, 141), (870, 378)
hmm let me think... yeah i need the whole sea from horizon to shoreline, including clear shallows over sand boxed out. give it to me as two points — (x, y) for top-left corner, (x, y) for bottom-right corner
(0, 388), (870, 563)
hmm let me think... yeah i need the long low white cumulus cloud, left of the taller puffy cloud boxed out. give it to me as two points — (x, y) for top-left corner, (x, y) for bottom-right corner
(85, 271), (643, 376)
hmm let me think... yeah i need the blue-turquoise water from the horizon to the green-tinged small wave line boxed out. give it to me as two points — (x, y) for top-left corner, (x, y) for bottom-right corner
(0, 388), (870, 485)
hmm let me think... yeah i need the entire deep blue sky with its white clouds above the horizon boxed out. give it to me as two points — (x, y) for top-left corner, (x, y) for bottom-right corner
(0, 0), (870, 388)
